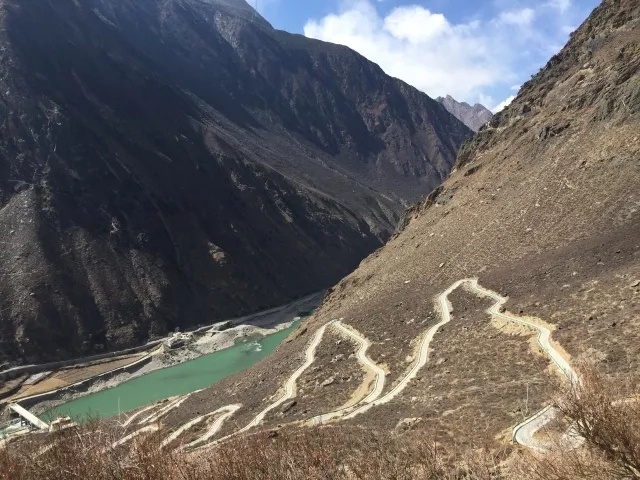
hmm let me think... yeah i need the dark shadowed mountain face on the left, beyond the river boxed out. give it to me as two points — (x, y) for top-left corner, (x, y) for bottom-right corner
(0, 0), (470, 362)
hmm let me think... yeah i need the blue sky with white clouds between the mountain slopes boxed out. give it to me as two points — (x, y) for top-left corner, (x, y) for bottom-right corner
(247, 0), (599, 111)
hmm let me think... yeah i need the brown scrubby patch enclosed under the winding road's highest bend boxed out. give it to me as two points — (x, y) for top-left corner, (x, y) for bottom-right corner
(365, 289), (555, 446)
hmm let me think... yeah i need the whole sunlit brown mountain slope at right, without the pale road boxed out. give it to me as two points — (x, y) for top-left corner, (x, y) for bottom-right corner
(156, 0), (640, 445)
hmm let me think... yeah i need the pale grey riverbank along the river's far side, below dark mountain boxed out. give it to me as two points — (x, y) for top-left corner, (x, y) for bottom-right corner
(7, 292), (323, 414)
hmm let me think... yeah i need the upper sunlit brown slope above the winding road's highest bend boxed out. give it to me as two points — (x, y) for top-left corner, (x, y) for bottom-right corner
(320, 0), (640, 435)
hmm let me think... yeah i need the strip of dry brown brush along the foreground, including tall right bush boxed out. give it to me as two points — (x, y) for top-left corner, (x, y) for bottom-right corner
(0, 366), (640, 480)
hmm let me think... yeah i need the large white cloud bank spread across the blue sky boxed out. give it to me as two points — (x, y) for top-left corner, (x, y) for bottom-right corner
(304, 0), (584, 108)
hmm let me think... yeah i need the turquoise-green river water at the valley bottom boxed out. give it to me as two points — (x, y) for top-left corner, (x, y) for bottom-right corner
(41, 321), (299, 421)
